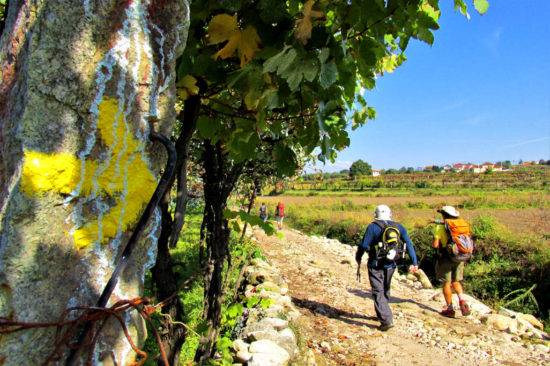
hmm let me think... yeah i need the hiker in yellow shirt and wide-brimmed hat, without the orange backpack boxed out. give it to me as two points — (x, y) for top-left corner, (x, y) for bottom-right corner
(432, 206), (471, 318)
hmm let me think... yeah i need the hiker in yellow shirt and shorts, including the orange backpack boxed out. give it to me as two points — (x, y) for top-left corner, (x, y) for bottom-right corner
(431, 206), (473, 318)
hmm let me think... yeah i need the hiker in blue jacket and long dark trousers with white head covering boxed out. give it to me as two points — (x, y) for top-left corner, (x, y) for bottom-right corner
(355, 205), (418, 331)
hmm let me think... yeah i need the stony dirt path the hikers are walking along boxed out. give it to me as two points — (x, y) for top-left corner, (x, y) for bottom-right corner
(254, 229), (550, 366)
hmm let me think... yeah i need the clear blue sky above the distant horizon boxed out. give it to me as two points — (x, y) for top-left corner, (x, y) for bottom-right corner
(317, 0), (550, 172)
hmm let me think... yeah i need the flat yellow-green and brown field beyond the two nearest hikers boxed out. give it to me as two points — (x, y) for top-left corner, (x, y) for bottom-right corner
(257, 191), (550, 240)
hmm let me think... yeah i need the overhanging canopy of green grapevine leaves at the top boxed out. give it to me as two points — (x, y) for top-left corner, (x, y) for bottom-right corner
(177, 0), (485, 175)
